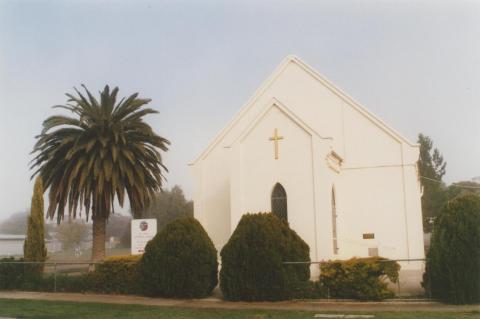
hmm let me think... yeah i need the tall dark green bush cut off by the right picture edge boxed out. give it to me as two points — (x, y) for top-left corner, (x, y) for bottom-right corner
(423, 195), (480, 304)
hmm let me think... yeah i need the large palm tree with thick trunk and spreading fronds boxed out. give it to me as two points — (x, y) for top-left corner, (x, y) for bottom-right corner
(31, 85), (170, 261)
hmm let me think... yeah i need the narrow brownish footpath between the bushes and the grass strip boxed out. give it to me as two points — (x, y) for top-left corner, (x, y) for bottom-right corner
(0, 291), (480, 312)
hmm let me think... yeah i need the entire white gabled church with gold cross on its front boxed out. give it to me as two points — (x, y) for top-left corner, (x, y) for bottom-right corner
(191, 56), (424, 282)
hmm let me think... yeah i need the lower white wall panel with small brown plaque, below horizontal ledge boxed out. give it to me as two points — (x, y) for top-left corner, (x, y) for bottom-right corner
(337, 168), (408, 259)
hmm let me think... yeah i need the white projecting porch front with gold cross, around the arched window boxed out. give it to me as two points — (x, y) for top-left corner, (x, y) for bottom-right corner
(232, 106), (316, 259)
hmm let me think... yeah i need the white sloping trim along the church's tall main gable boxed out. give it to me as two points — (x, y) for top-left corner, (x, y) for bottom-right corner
(191, 55), (418, 165)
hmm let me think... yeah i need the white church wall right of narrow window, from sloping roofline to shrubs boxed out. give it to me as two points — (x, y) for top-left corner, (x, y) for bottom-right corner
(338, 107), (423, 259)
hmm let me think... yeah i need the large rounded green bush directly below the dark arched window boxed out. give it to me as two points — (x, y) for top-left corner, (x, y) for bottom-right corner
(220, 213), (310, 301)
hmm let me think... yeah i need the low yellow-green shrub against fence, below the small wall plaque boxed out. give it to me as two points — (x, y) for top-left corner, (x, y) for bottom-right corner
(320, 257), (400, 300)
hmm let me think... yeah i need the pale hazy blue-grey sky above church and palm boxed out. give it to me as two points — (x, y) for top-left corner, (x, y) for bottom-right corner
(0, 0), (480, 219)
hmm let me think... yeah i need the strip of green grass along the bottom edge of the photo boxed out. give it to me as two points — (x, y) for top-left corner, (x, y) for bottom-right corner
(0, 297), (480, 319)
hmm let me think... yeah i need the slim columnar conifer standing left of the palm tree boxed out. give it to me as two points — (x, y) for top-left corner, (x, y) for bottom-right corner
(23, 177), (47, 273)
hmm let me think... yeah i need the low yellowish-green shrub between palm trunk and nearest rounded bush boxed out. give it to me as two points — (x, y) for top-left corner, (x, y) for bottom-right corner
(86, 256), (141, 294)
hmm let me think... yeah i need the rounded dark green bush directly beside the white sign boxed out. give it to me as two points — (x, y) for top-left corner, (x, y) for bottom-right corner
(139, 218), (218, 298)
